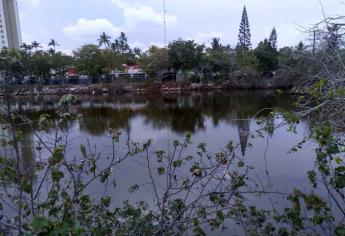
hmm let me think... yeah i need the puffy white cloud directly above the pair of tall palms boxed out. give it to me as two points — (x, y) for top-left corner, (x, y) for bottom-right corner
(63, 18), (122, 42)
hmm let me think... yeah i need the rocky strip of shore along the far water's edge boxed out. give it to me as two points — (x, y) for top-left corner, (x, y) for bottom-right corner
(0, 81), (291, 97)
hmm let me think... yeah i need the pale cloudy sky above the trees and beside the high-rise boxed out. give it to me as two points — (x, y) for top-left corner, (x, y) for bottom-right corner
(17, 0), (345, 52)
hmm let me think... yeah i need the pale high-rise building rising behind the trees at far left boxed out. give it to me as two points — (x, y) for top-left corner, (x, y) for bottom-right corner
(0, 0), (22, 49)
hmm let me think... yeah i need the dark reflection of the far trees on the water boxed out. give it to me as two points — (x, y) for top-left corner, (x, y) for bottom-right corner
(7, 91), (290, 136)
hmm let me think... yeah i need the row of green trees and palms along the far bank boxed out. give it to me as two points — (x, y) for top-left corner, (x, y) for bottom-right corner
(0, 7), (342, 84)
